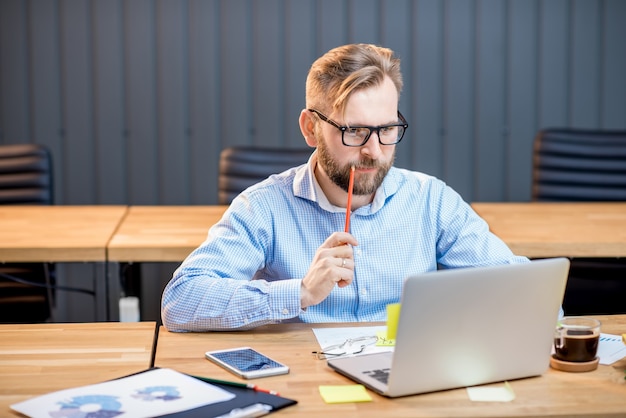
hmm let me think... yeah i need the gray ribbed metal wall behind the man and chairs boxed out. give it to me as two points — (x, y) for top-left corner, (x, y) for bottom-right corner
(0, 0), (626, 204)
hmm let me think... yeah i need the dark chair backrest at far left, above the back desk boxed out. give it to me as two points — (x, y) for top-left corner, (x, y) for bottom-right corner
(0, 144), (54, 205)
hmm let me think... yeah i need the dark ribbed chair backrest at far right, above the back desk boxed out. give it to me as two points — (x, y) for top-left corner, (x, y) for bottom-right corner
(532, 129), (626, 202)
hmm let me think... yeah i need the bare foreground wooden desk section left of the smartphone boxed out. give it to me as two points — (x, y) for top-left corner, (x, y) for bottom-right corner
(0, 322), (156, 416)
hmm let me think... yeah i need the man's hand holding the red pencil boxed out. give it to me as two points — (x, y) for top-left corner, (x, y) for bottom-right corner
(300, 232), (358, 308)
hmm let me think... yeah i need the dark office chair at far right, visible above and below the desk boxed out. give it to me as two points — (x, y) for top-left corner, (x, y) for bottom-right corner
(532, 129), (626, 315)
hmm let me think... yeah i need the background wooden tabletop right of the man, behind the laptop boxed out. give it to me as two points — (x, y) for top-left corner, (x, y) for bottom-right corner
(472, 203), (626, 257)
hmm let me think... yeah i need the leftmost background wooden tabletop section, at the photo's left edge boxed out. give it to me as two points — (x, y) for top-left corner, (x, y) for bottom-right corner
(0, 206), (127, 262)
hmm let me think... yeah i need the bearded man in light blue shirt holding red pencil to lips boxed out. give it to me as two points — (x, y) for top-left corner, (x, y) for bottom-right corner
(162, 44), (528, 331)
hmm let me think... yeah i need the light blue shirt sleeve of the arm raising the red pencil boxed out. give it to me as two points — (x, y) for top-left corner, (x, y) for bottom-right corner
(162, 199), (301, 332)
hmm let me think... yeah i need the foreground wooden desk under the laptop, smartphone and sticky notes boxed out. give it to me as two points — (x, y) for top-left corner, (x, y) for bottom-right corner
(155, 315), (626, 417)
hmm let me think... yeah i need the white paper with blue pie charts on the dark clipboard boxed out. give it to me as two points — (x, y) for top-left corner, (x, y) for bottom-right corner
(11, 369), (235, 418)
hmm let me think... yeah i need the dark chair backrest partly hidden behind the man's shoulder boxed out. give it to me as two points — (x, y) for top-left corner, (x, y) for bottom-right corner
(218, 146), (313, 205)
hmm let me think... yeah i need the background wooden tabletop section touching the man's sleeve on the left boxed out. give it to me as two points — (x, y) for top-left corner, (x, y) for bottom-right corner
(108, 206), (227, 262)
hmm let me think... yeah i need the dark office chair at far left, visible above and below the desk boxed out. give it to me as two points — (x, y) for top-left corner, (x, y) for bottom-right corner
(0, 144), (55, 323)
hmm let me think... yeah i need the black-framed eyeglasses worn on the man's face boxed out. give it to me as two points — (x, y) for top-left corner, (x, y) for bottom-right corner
(307, 109), (409, 147)
